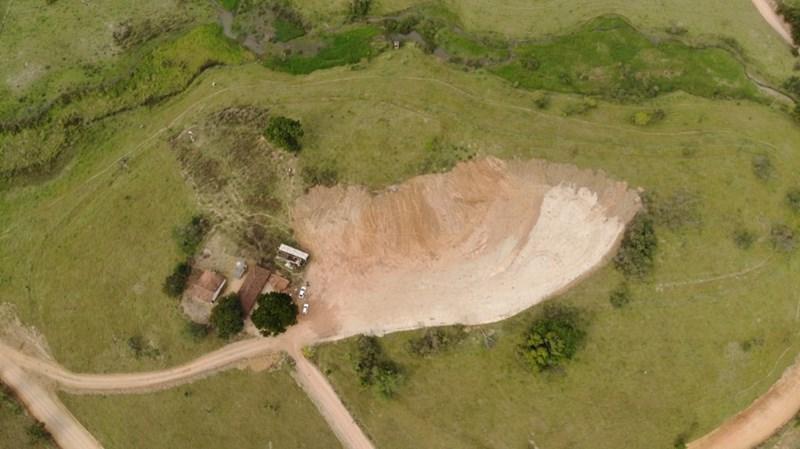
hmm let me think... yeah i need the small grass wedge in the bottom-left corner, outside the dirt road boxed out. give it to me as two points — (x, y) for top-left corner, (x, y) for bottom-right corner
(0, 384), (56, 449)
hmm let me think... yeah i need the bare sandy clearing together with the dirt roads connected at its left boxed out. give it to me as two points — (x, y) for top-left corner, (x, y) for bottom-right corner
(0, 159), (639, 449)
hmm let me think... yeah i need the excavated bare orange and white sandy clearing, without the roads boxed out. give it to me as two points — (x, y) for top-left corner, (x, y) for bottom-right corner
(293, 158), (640, 337)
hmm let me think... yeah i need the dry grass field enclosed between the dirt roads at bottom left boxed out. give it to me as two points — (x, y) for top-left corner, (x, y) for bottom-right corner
(62, 368), (341, 449)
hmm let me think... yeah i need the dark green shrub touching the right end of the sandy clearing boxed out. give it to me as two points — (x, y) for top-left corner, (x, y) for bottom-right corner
(614, 212), (658, 277)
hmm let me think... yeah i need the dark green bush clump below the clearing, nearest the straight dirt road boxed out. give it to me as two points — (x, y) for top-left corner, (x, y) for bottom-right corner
(354, 335), (402, 398)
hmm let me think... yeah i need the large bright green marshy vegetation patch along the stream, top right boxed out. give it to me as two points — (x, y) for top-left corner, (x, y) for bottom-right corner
(492, 16), (757, 99)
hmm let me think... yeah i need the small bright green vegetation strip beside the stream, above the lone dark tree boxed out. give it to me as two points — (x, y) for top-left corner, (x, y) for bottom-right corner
(265, 25), (380, 75)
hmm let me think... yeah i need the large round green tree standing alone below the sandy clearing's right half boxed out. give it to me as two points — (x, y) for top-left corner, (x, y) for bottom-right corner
(520, 304), (586, 371)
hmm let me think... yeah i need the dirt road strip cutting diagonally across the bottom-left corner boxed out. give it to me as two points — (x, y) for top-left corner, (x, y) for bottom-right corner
(0, 356), (103, 449)
